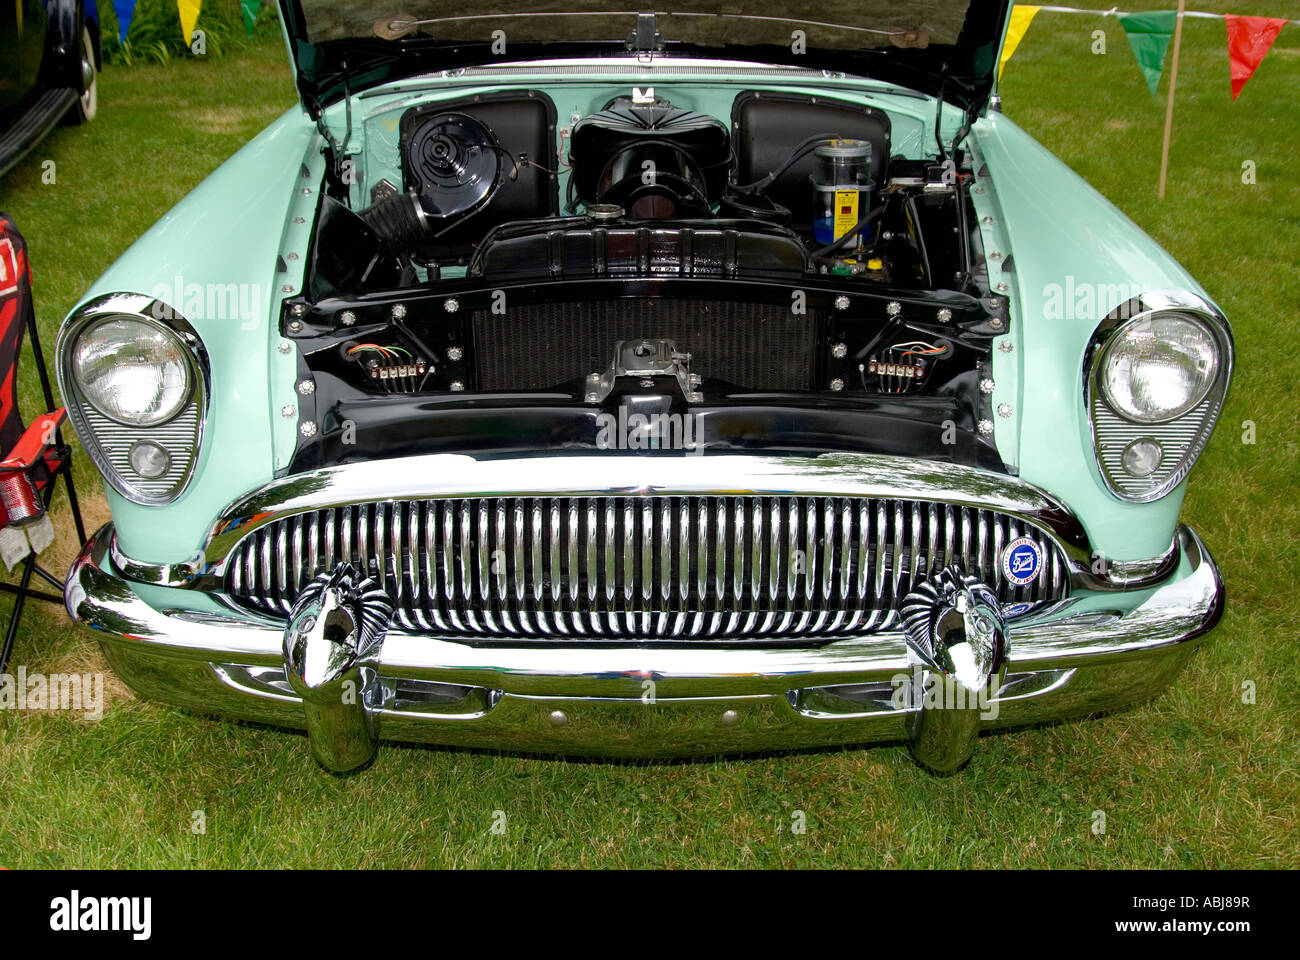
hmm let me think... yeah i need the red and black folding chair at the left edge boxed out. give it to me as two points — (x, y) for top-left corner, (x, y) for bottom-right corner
(0, 213), (86, 674)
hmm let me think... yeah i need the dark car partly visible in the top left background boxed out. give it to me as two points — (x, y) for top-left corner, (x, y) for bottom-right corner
(0, 0), (101, 176)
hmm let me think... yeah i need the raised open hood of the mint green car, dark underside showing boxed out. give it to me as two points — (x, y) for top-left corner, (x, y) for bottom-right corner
(280, 0), (1011, 117)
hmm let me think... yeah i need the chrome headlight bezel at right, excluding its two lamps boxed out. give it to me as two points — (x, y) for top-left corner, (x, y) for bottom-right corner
(1083, 290), (1234, 503)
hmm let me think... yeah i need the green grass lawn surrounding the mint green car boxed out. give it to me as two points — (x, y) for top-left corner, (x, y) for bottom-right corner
(0, 0), (1300, 868)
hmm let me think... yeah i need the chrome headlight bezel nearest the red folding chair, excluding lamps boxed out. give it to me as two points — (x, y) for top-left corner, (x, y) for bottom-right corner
(55, 293), (212, 505)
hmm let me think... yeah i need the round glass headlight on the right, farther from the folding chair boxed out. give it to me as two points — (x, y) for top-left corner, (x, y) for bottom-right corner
(1099, 313), (1218, 423)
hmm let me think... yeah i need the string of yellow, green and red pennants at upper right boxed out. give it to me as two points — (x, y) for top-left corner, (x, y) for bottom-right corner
(998, 4), (1300, 100)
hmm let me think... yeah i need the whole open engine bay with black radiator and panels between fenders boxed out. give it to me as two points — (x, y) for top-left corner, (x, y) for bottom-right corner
(282, 80), (1009, 467)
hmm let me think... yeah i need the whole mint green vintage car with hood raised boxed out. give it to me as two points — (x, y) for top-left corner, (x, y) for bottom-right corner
(59, 0), (1232, 773)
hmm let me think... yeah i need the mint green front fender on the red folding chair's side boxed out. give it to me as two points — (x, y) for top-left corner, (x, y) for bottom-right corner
(74, 107), (321, 563)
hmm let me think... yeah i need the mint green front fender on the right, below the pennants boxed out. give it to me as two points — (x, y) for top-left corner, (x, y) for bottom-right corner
(971, 113), (1212, 561)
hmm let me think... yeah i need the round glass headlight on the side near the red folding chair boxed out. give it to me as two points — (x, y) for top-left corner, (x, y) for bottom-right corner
(72, 316), (190, 427)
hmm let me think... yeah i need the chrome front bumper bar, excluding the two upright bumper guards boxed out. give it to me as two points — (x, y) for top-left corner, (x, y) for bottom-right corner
(65, 526), (1223, 757)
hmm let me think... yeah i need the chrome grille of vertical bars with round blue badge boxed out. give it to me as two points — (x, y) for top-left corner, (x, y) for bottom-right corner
(226, 496), (1067, 640)
